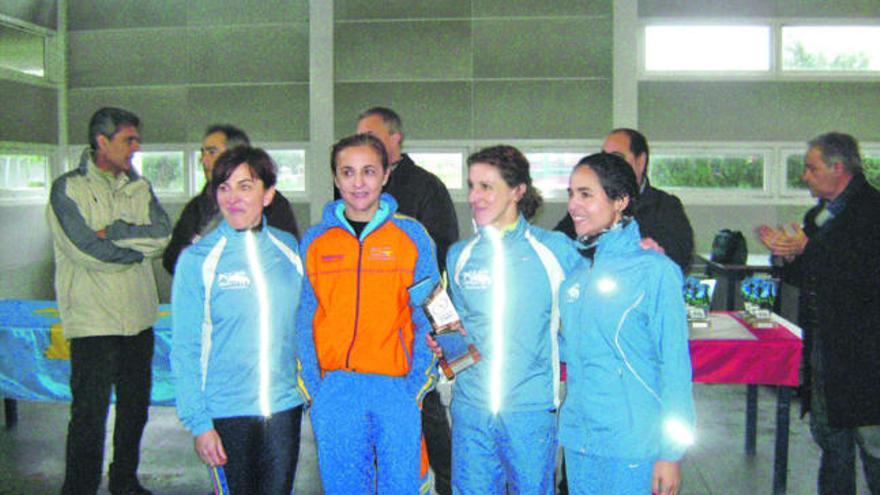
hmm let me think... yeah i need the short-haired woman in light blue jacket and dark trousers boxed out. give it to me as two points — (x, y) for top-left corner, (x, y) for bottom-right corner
(171, 147), (303, 494)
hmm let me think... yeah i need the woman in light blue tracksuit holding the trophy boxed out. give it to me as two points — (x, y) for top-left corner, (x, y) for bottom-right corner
(446, 146), (581, 495)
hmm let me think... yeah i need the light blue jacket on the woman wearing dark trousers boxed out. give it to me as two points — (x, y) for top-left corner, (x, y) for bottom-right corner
(171, 218), (303, 436)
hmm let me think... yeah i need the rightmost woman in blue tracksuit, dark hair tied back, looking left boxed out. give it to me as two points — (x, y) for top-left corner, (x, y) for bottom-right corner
(559, 153), (694, 495)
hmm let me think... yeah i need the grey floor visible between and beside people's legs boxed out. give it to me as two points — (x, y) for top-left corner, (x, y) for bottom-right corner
(0, 384), (867, 495)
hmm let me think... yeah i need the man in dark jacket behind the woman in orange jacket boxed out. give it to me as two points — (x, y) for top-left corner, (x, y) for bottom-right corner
(357, 107), (458, 495)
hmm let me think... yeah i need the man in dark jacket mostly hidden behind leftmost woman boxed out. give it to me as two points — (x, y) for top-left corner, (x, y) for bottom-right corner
(162, 124), (299, 274)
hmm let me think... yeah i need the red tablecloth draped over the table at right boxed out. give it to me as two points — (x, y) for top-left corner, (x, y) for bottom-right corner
(689, 312), (803, 387)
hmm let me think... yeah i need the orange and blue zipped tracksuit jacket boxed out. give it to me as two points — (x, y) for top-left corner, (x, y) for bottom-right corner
(297, 194), (439, 401)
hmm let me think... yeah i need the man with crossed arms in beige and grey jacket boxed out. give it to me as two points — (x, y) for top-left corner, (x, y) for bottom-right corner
(46, 108), (171, 495)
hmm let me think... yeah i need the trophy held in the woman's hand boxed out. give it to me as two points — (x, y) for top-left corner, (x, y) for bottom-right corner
(409, 279), (480, 380)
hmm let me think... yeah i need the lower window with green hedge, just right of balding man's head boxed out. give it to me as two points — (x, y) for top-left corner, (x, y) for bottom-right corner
(648, 150), (767, 190)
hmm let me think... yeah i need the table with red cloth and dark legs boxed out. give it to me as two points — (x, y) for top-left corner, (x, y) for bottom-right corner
(689, 311), (803, 494)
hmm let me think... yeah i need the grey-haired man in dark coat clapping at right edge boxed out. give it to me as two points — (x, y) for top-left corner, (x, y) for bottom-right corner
(758, 132), (880, 495)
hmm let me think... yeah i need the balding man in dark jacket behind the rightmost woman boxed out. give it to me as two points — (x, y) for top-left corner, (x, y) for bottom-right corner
(556, 128), (694, 273)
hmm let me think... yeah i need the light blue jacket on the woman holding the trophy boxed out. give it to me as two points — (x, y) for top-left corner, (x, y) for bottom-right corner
(446, 216), (582, 412)
